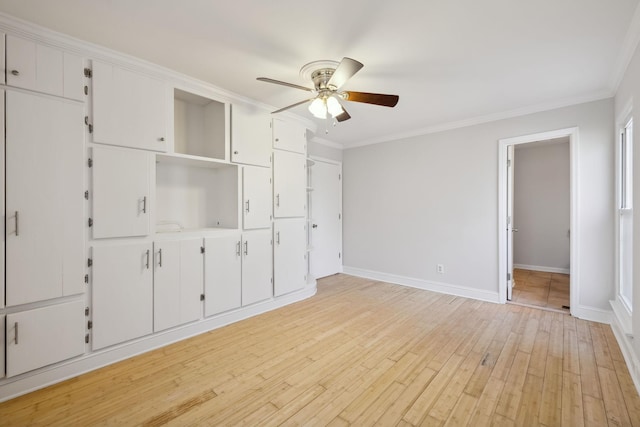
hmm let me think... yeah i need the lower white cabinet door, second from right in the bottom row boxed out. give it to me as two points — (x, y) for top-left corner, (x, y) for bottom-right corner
(242, 229), (273, 305)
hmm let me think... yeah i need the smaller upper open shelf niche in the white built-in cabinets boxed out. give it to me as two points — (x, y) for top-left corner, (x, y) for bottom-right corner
(174, 89), (229, 160)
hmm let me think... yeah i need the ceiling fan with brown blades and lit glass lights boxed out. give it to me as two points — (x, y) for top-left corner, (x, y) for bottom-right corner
(258, 57), (400, 122)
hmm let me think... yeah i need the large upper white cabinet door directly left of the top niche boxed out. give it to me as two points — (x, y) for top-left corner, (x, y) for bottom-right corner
(92, 61), (168, 151)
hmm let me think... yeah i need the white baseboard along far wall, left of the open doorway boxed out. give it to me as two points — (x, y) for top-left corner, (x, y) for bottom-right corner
(342, 266), (500, 303)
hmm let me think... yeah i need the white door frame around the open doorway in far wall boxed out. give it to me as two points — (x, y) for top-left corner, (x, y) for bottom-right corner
(498, 127), (580, 314)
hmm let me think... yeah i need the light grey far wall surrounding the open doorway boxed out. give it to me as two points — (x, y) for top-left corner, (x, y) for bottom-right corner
(343, 99), (614, 312)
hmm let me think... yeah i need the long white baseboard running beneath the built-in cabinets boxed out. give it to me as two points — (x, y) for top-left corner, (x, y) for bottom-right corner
(0, 280), (317, 402)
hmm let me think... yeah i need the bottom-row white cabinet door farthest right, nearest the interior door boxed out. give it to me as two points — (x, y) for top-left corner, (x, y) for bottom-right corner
(273, 218), (307, 296)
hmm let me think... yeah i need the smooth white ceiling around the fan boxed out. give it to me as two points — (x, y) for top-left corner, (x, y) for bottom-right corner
(0, 0), (640, 147)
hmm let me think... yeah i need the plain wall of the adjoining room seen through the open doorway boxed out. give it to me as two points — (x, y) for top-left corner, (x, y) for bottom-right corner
(513, 142), (571, 272)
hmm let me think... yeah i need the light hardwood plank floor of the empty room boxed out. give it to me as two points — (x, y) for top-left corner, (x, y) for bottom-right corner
(0, 275), (640, 426)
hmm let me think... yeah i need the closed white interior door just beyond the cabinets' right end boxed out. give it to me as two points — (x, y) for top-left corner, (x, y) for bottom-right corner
(309, 161), (342, 278)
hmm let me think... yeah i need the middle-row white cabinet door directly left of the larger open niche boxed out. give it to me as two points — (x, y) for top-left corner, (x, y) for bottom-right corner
(92, 147), (152, 239)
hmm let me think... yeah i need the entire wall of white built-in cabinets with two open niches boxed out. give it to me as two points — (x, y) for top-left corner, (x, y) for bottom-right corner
(0, 20), (316, 397)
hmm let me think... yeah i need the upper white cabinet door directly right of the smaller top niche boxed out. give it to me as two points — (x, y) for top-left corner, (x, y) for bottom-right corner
(231, 105), (271, 167)
